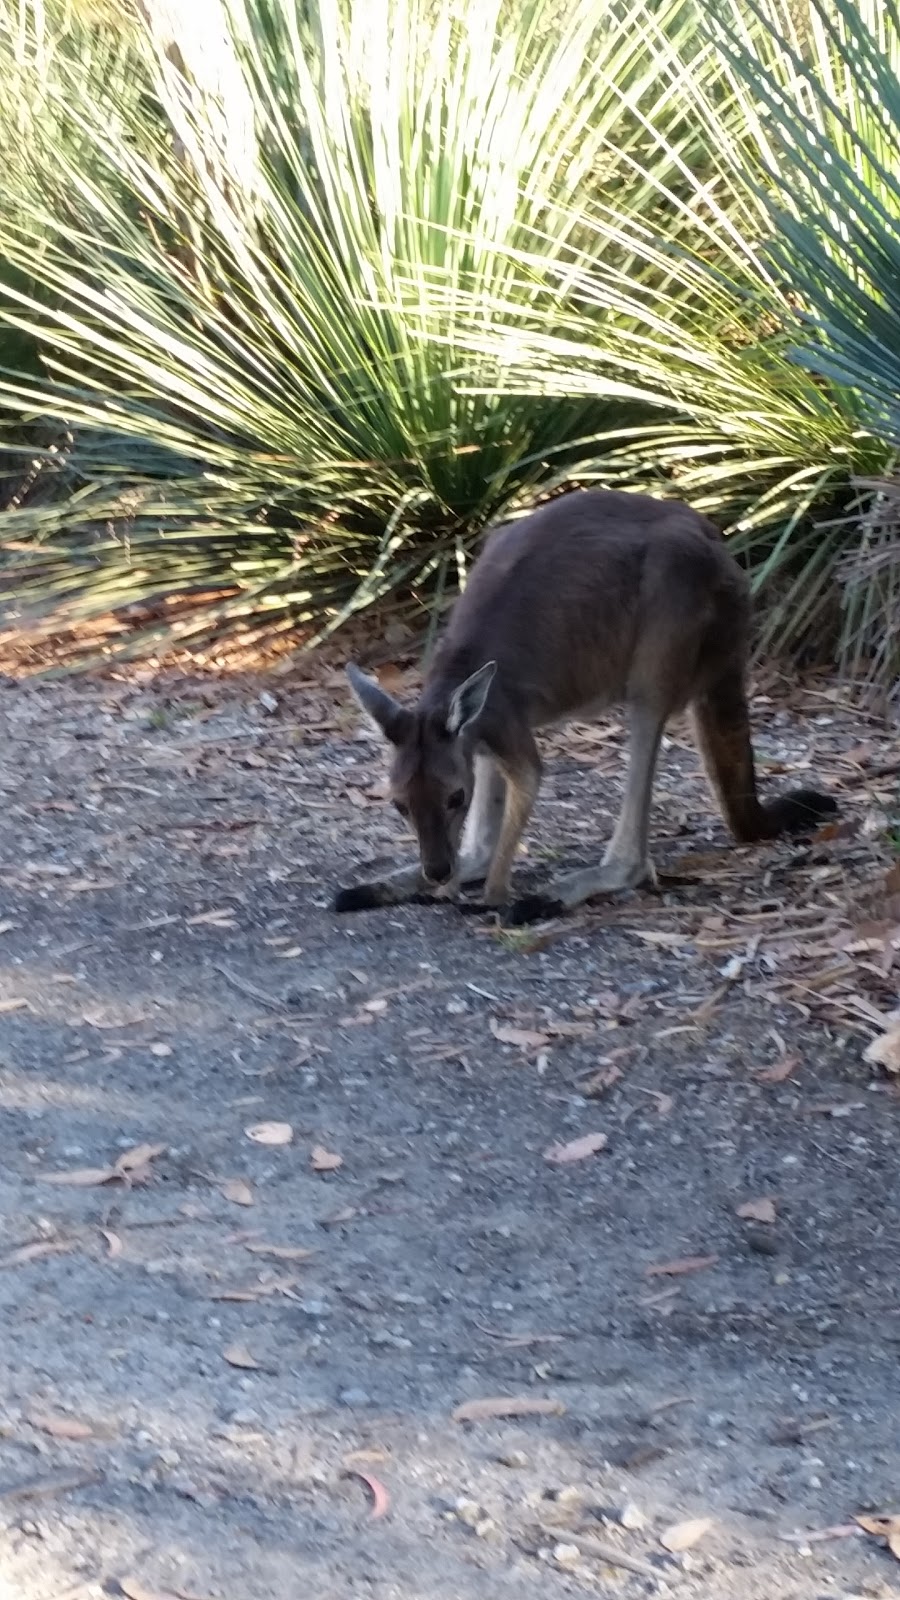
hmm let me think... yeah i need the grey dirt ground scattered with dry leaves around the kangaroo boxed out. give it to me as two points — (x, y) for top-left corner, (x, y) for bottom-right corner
(0, 652), (900, 1600)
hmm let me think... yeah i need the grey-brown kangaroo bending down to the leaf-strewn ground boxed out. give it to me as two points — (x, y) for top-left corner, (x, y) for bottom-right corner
(335, 490), (836, 922)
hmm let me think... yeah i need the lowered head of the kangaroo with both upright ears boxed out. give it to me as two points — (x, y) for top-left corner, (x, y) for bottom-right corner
(348, 661), (496, 888)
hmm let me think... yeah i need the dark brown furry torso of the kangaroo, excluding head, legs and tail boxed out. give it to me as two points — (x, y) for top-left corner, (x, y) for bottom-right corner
(429, 490), (748, 726)
